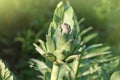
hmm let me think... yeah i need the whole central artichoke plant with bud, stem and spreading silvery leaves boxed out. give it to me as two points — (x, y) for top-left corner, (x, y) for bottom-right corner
(30, 2), (119, 80)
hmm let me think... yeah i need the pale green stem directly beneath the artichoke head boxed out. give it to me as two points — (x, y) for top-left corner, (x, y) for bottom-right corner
(51, 62), (59, 80)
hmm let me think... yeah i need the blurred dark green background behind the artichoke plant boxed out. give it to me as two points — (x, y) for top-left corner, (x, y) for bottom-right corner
(0, 0), (120, 80)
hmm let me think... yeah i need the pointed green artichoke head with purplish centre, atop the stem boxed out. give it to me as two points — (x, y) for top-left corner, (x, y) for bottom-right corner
(34, 2), (79, 62)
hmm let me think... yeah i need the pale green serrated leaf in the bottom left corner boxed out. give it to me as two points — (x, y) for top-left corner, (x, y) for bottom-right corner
(0, 59), (15, 80)
